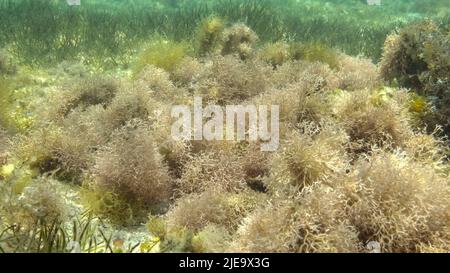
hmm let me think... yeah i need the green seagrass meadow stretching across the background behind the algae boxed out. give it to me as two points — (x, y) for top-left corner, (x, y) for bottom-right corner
(0, 0), (450, 65)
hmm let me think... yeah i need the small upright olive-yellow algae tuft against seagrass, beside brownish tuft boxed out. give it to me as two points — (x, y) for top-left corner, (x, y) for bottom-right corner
(196, 16), (225, 56)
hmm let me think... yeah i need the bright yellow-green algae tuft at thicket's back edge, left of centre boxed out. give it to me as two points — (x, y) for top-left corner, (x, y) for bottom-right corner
(133, 39), (188, 76)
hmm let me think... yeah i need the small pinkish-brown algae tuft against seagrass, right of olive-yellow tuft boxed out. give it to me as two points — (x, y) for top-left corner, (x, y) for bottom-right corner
(222, 24), (258, 60)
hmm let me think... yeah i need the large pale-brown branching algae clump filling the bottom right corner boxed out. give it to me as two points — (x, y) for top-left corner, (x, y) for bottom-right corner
(349, 151), (450, 252)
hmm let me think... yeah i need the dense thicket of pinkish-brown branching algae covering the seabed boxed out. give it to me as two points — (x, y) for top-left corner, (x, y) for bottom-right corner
(0, 1), (450, 252)
